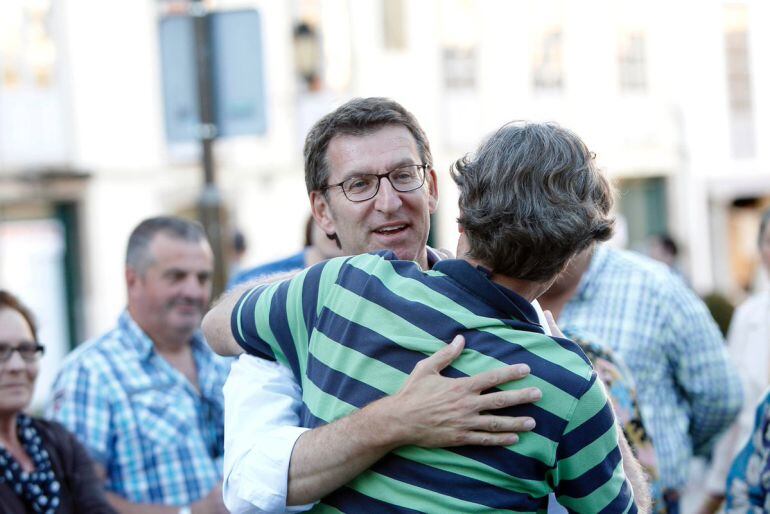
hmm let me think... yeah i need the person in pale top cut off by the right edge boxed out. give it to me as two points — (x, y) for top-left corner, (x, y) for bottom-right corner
(700, 210), (770, 514)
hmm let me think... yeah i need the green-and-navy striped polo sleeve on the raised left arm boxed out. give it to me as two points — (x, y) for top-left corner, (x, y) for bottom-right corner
(230, 259), (344, 377)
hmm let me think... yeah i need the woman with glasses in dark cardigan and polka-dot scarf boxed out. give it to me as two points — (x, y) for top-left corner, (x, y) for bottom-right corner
(0, 289), (114, 514)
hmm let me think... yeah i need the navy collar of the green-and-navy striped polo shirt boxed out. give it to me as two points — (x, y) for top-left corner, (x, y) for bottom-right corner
(433, 259), (542, 326)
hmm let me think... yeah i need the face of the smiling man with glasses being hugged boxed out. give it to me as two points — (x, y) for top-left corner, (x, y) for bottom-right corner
(310, 125), (438, 267)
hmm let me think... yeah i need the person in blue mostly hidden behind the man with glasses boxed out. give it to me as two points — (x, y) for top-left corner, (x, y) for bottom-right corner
(227, 210), (342, 289)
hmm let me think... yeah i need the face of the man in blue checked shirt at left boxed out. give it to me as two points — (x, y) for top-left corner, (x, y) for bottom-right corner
(126, 232), (214, 338)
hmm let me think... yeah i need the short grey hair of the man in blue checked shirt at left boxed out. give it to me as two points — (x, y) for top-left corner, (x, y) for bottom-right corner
(126, 216), (207, 275)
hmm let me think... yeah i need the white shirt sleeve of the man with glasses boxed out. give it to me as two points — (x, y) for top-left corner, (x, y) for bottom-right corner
(223, 355), (313, 514)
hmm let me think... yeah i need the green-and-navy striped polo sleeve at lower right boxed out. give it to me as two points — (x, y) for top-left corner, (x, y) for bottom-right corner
(553, 372), (636, 513)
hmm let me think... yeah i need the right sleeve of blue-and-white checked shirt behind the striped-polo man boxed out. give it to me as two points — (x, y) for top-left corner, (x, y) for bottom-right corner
(662, 278), (743, 455)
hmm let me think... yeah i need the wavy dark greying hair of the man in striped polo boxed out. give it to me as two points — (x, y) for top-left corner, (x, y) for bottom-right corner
(451, 122), (614, 282)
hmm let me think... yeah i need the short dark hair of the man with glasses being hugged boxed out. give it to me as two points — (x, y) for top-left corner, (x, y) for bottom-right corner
(304, 97), (433, 193)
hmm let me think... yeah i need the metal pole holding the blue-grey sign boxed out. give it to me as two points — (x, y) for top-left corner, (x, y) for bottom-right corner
(190, 0), (227, 297)
